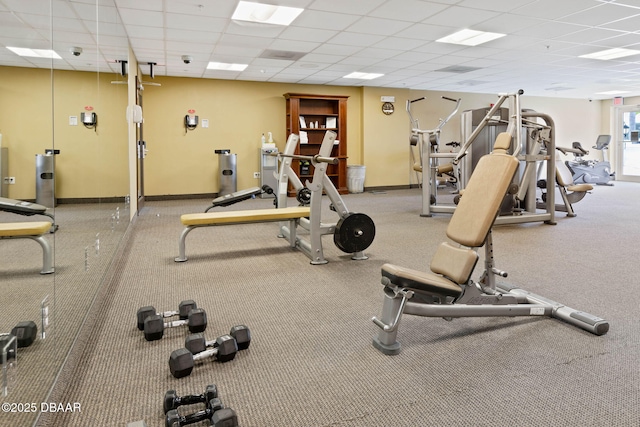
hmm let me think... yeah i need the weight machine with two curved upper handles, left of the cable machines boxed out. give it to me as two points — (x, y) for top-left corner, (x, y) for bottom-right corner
(406, 96), (468, 217)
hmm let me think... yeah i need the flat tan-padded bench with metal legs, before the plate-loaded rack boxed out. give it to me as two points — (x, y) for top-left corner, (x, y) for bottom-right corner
(175, 206), (311, 262)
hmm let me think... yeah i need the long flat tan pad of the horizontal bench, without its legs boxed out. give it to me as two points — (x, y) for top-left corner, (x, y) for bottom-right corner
(180, 206), (311, 226)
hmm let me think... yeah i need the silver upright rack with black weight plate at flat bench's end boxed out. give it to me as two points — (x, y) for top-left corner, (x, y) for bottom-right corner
(273, 131), (375, 264)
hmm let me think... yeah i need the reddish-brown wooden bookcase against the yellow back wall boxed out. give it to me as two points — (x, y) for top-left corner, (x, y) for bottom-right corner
(284, 93), (349, 196)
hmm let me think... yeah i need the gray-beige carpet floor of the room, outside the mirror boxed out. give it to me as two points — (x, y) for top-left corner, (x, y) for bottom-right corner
(32, 182), (640, 427)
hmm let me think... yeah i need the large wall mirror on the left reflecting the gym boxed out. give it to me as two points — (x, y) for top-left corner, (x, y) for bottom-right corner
(0, 0), (129, 425)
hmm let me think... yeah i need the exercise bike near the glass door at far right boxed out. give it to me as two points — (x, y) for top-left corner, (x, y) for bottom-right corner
(561, 135), (616, 185)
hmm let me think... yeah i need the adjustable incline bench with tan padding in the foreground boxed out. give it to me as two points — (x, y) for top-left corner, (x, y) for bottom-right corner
(372, 132), (609, 354)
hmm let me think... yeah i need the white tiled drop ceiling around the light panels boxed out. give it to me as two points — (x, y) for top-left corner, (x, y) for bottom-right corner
(0, 0), (640, 97)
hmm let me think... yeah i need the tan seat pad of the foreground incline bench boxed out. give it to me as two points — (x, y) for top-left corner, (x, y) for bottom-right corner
(382, 264), (462, 297)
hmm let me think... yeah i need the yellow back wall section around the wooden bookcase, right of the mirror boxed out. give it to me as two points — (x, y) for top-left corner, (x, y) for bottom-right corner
(143, 77), (361, 196)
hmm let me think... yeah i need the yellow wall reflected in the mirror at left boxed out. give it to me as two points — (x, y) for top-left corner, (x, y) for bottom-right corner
(0, 67), (129, 199)
